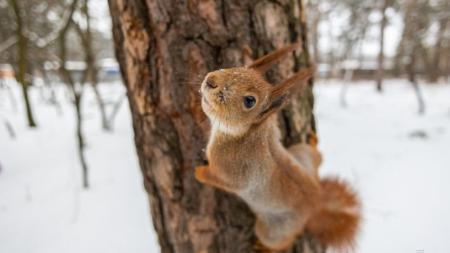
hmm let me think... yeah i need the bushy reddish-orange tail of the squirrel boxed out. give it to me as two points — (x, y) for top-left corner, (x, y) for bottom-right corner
(306, 178), (361, 250)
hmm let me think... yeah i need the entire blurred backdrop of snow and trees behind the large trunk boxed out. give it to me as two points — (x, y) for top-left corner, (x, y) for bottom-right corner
(0, 0), (450, 252)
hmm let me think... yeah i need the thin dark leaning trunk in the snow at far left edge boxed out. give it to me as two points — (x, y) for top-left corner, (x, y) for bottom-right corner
(9, 0), (36, 127)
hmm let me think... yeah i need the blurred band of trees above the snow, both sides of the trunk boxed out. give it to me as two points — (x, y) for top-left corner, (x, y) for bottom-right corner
(0, 0), (450, 130)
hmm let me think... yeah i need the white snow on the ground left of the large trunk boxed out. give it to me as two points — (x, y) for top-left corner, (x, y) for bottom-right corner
(0, 81), (159, 253)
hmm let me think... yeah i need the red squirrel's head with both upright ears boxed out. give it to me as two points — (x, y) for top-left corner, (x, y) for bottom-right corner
(200, 44), (313, 136)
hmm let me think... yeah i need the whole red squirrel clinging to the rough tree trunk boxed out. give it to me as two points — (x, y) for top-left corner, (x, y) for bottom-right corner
(195, 43), (360, 250)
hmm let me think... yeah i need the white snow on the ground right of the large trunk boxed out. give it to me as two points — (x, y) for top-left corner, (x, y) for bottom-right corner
(315, 80), (450, 253)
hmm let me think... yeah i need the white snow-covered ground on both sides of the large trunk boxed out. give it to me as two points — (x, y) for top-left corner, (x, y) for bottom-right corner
(0, 78), (450, 253)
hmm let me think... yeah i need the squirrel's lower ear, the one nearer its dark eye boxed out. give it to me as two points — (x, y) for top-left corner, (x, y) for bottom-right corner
(260, 67), (315, 122)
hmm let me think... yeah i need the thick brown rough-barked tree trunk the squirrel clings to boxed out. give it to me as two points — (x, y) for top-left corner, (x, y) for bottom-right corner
(109, 0), (324, 253)
